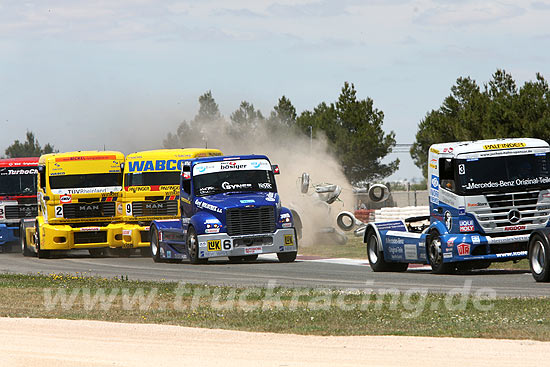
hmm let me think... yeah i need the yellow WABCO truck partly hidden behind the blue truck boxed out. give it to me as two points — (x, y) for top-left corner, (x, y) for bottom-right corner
(120, 148), (222, 256)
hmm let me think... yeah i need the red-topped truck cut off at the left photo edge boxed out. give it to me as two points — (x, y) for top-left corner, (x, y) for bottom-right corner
(0, 157), (38, 252)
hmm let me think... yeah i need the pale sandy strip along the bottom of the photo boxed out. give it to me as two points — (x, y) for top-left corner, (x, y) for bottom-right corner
(0, 318), (550, 367)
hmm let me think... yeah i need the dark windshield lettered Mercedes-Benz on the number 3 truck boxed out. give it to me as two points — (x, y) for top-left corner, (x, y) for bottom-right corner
(455, 153), (550, 195)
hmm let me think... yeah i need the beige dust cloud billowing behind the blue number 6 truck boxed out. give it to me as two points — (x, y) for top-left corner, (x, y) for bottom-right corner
(165, 119), (354, 246)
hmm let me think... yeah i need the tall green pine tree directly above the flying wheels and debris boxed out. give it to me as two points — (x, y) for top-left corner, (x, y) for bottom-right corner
(297, 82), (399, 184)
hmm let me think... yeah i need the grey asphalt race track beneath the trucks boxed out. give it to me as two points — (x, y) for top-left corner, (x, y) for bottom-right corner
(0, 251), (550, 297)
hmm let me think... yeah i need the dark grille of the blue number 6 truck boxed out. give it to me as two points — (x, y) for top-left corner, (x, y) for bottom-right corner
(227, 206), (275, 236)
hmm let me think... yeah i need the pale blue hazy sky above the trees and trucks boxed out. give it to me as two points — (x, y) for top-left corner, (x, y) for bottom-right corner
(0, 0), (550, 180)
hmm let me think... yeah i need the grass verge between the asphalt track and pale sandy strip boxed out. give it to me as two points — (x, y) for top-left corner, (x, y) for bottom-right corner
(0, 274), (550, 341)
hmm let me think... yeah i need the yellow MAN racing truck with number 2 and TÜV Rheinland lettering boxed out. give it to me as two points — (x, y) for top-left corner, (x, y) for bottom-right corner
(21, 151), (124, 258)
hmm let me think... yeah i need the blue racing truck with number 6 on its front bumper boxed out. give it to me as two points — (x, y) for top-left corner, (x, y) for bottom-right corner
(150, 155), (298, 264)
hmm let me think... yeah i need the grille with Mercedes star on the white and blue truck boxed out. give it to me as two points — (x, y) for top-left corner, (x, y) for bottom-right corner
(471, 190), (550, 232)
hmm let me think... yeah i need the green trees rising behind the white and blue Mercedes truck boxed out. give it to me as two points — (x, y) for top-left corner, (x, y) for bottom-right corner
(411, 70), (550, 177)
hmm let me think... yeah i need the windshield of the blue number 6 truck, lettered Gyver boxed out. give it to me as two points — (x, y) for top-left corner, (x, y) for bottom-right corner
(193, 170), (277, 196)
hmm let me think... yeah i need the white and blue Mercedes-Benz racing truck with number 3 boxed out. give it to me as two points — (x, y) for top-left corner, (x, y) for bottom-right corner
(364, 139), (550, 273)
